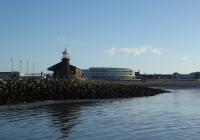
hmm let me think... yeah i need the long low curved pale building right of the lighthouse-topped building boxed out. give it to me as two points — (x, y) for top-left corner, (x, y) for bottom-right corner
(82, 67), (135, 80)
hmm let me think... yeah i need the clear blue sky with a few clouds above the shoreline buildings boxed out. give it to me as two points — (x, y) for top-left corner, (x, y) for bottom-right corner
(0, 0), (200, 74)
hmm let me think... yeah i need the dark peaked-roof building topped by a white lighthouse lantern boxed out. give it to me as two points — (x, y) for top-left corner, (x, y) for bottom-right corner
(48, 49), (81, 78)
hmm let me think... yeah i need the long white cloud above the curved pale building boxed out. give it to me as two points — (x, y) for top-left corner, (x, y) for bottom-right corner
(106, 47), (162, 56)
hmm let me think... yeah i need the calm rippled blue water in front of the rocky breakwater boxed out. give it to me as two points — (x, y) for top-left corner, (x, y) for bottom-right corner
(0, 89), (200, 140)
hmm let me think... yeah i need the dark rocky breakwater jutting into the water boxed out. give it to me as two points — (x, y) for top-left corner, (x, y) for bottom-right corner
(0, 79), (166, 105)
